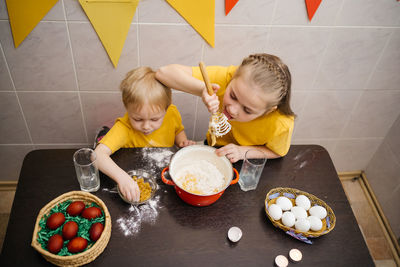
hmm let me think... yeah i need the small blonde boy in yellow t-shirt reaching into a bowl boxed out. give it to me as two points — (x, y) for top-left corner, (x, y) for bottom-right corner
(95, 67), (195, 201)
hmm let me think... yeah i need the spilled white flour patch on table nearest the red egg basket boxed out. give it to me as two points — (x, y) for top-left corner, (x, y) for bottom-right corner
(117, 196), (160, 236)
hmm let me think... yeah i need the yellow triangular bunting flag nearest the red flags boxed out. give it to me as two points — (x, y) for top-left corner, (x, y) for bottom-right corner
(166, 0), (215, 47)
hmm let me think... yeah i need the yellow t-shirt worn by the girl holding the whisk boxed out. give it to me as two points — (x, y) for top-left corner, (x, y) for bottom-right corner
(192, 66), (294, 156)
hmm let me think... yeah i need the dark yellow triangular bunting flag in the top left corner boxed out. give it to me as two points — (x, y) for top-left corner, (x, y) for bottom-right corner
(6, 0), (58, 48)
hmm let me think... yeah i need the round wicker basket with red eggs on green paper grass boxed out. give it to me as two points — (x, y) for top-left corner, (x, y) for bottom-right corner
(31, 191), (111, 266)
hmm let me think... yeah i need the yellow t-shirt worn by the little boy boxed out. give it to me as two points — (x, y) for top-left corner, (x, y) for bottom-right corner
(100, 105), (184, 153)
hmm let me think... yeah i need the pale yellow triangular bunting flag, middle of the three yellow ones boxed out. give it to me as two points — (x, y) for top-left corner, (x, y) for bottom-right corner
(79, 0), (139, 68)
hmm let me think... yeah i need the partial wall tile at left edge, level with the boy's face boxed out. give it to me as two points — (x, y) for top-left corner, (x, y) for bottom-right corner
(0, 92), (31, 144)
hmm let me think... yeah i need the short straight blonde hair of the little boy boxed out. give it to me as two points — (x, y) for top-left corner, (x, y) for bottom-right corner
(120, 67), (172, 110)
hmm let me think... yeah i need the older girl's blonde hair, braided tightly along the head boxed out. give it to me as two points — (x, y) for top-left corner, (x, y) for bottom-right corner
(233, 53), (295, 116)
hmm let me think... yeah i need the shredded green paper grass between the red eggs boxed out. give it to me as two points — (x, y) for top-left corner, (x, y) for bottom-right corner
(37, 200), (105, 256)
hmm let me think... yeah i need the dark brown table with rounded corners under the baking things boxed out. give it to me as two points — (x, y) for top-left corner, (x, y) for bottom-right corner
(0, 145), (374, 267)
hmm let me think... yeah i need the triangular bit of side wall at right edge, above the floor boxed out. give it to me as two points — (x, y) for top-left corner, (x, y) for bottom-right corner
(365, 116), (400, 238)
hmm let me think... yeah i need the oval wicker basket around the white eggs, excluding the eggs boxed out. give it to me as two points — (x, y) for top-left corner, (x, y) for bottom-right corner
(265, 187), (336, 237)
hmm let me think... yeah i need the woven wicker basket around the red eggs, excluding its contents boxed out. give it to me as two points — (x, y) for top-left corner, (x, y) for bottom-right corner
(31, 191), (111, 266)
